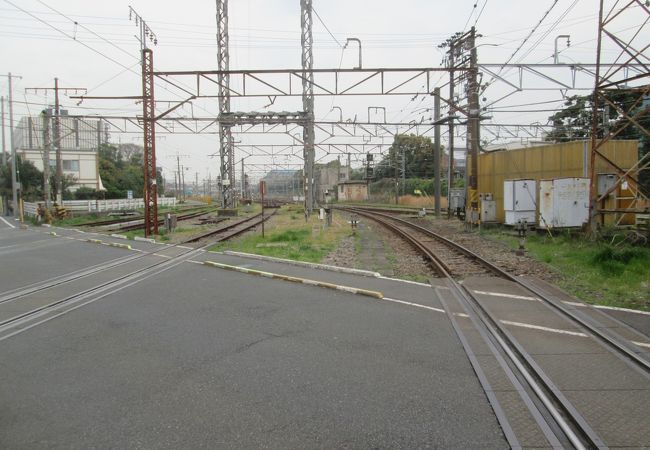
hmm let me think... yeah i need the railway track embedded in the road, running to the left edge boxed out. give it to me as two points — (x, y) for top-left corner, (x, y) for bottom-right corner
(0, 214), (273, 341)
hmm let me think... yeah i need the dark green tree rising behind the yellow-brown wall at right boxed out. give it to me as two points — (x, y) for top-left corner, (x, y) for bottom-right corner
(546, 89), (650, 196)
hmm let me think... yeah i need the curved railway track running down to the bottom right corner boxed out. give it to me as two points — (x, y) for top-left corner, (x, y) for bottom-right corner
(339, 207), (650, 449)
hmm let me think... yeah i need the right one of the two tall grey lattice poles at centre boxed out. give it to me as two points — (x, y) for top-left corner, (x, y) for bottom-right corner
(300, 0), (315, 214)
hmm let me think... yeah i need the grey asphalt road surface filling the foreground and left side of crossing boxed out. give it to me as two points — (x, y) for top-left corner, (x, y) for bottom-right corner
(0, 230), (507, 448)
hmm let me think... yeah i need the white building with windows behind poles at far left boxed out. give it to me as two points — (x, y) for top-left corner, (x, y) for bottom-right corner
(14, 114), (108, 192)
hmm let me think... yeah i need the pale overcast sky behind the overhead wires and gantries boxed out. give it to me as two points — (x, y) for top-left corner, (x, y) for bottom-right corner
(0, 0), (647, 183)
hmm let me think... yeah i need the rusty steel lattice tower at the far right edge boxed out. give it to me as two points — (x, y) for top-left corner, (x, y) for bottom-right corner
(590, 0), (650, 231)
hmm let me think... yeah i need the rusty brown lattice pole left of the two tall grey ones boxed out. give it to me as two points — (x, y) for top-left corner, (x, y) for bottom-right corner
(142, 48), (158, 236)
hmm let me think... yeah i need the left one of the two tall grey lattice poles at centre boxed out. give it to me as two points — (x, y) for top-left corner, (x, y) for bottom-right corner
(217, 0), (235, 208)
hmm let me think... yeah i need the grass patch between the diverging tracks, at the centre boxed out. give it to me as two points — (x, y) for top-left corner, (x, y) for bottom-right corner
(209, 207), (349, 262)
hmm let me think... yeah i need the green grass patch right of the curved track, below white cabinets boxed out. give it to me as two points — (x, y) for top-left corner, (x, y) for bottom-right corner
(486, 231), (650, 311)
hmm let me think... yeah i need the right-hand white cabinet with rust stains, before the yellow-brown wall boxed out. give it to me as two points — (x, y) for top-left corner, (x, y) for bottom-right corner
(539, 178), (589, 229)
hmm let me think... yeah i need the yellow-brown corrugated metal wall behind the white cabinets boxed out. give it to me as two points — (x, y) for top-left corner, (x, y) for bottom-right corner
(478, 141), (638, 222)
